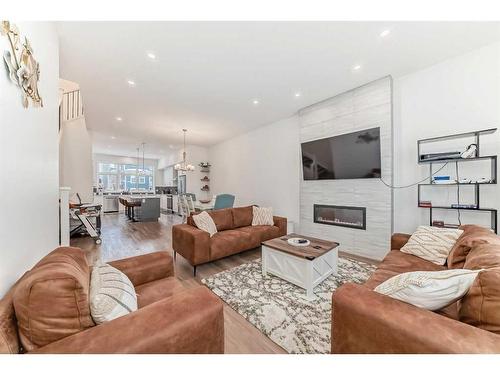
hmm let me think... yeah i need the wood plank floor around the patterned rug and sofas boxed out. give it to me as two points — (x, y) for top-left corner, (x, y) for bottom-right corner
(71, 213), (286, 354)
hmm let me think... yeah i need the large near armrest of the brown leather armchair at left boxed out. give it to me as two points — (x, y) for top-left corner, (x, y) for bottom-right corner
(30, 286), (224, 354)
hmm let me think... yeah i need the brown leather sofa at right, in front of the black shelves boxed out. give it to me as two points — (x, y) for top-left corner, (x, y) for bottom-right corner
(332, 225), (500, 353)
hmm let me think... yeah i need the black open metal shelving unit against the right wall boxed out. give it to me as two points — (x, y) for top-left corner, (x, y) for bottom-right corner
(417, 128), (498, 233)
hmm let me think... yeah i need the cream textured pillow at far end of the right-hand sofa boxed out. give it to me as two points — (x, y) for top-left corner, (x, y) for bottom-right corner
(401, 225), (464, 266)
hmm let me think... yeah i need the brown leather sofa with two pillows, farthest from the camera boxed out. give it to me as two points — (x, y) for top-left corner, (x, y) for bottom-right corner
(172, 206), (287, 275)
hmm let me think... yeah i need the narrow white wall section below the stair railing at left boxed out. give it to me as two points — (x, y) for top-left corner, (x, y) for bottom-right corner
(59, 117), (94, 202)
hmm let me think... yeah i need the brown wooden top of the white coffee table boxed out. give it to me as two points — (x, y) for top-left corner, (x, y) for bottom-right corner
(262, 233), (339, 260)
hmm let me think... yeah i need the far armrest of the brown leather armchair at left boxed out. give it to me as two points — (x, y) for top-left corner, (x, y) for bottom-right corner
(109, 251), (174, 286)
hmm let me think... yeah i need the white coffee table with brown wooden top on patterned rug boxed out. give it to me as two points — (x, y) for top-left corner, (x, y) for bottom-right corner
(262, 233), (339, 300)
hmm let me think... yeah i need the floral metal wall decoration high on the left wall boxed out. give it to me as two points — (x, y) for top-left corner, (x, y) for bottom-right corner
(0, 21), (43, 108)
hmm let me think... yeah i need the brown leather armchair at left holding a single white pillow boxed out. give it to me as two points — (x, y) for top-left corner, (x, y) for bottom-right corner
(0, 247), (224, 353)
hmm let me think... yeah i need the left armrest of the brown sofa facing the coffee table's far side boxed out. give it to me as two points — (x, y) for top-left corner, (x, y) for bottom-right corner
(172, 224), (210, 266)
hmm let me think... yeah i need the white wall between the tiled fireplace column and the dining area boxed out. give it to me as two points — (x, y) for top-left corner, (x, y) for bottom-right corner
(209, 116), (300, 223)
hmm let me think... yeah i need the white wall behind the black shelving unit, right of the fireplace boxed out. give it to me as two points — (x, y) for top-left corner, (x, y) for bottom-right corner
(394, 43), (500, 233)
